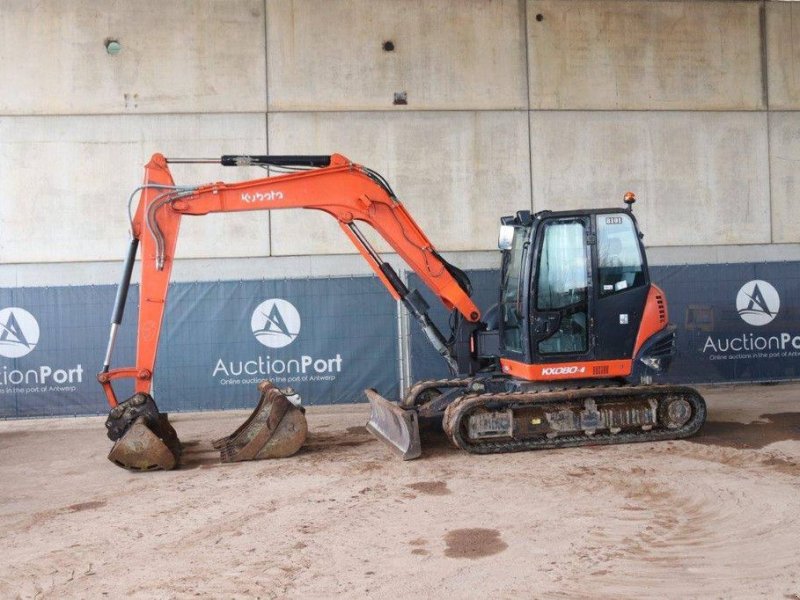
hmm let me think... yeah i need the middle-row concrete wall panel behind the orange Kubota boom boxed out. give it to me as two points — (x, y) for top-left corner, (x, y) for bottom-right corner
(269, 111), (530, 255)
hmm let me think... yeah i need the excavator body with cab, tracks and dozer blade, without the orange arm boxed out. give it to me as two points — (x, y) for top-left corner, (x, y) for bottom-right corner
(368, 195), (706, 459)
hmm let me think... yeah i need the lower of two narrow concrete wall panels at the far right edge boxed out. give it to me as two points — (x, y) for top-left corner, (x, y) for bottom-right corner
(769, 112), (800, 244)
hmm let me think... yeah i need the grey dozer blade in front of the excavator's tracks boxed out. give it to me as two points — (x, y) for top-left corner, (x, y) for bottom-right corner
(364, 389), (422, 460)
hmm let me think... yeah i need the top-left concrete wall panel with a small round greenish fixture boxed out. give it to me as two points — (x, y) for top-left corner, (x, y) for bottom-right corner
(0, 0), (266, 115)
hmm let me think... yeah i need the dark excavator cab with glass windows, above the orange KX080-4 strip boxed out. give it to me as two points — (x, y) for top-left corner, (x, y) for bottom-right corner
(499, 209), (666, 375)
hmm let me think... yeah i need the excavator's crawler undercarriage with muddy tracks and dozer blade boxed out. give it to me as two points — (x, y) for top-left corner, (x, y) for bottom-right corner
(368, 378), (706, 460)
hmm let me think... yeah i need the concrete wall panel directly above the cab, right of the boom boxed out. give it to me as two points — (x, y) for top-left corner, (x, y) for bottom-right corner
(530, 112), (770, 246)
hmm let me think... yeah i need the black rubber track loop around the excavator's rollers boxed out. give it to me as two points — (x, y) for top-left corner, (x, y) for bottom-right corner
(444, 385), (706, 454)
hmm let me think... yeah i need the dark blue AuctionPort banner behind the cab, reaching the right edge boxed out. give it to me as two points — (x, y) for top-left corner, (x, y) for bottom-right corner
(409, 262), (800, 383)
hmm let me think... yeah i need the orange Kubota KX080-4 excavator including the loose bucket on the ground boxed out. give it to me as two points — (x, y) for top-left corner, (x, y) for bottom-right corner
(98, 154), (706, 470)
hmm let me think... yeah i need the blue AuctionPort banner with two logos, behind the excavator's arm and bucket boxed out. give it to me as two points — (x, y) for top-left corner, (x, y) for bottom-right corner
(0, 277), (399, 417)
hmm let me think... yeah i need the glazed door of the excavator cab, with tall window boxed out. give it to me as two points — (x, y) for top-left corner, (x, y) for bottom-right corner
(530, 216), (594, 363)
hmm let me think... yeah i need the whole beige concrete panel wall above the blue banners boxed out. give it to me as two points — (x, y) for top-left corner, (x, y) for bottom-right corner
(0, 0), (800, 286)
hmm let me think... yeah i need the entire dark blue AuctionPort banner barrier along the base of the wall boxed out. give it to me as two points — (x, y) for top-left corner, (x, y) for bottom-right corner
(0, 262), (800, 418)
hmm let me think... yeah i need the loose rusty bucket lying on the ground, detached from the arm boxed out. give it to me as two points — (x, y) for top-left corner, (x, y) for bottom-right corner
(213, 381), (308, 462)
